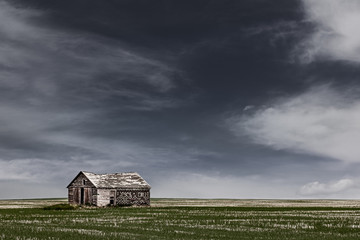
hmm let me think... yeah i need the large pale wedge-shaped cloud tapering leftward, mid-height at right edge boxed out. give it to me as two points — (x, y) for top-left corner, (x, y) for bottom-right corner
(228, 85), (360, 162)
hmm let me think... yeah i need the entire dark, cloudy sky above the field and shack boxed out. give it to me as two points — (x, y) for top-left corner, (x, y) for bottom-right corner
(0, 0), (360, 199)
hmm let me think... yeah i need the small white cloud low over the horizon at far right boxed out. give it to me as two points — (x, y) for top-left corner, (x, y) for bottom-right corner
(299, 178), (356, 196)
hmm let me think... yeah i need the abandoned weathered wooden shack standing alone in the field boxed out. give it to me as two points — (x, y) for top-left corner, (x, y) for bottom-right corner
(67, 171), (151, 207)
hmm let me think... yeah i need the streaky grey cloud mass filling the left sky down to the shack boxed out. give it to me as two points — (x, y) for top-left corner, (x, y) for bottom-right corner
(0, 0), (193, 195)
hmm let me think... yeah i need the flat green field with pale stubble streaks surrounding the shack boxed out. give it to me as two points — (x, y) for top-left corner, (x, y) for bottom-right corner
(0, 199), (360, 240)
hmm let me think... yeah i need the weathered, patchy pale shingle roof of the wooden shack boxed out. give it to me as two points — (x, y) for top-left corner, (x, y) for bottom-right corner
(68, 171), (151, 189)
